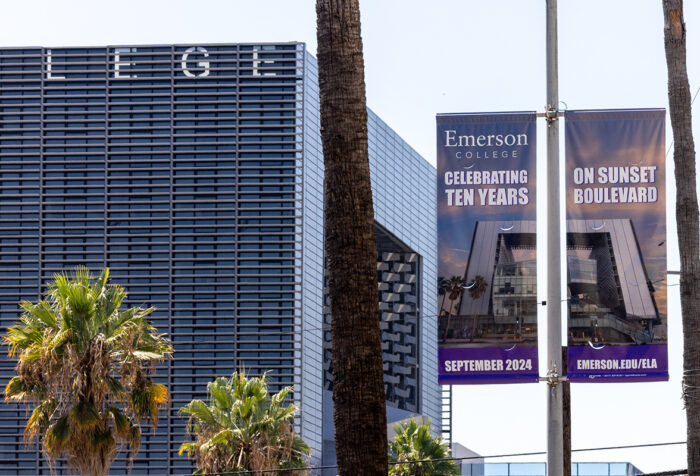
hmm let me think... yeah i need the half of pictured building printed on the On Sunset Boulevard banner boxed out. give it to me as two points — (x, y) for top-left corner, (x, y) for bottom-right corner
(566, 218), (667, 345)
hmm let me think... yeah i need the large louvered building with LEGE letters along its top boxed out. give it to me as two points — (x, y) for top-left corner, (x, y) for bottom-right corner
(0, 43), (440, 474)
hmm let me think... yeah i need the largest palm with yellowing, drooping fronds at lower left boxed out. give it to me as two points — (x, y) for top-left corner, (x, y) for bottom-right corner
(4, 267), (172, 476)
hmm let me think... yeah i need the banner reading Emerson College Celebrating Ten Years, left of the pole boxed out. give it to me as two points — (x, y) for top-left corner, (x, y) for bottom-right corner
(437, 112), (538, 384)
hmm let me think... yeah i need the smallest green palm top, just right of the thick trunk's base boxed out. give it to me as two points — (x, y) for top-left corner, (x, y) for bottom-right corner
(389, 417), (461, 476)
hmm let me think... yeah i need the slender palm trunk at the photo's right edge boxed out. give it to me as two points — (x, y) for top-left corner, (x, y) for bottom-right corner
(663, 0), (700, 476)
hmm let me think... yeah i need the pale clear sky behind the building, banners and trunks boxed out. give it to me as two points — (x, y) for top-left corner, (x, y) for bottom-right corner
(0, 0), (700, 472)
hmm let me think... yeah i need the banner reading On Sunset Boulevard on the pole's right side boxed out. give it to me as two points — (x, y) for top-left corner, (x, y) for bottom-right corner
(565, 109), (668, 382)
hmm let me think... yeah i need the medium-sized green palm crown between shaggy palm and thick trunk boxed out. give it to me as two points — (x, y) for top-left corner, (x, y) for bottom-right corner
(180, 372), (311, 476)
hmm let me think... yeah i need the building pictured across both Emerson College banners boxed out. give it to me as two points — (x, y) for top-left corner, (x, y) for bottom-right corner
(447, 218), (667, 345)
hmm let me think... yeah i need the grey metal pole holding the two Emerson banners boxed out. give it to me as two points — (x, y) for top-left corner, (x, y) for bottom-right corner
(545, 0), (564, 476)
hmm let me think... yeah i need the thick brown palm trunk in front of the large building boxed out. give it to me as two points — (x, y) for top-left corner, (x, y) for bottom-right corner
(316, 0), (388, 476)
